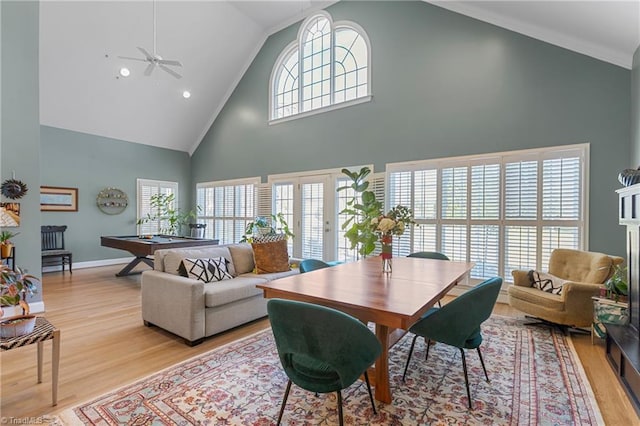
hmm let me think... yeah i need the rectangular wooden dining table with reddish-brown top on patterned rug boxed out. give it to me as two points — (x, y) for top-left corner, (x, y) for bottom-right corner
(257, 256), (474, 403)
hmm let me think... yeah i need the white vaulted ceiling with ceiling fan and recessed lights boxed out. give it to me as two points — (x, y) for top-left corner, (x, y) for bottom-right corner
(40, 0), (640, 153)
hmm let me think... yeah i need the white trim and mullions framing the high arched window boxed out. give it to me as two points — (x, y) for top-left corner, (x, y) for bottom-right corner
(268, 11), (373, 125)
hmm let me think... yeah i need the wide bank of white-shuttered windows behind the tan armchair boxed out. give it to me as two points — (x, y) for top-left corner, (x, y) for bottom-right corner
(387, 144), (588, 280)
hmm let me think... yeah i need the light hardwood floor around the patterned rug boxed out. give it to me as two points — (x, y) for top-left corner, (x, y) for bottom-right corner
(0, 265), (640, 425)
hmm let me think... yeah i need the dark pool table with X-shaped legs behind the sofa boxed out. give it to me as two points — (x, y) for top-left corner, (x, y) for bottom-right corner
(100, 235), (218, 277)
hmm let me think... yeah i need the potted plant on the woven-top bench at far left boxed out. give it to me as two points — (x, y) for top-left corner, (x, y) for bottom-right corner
(0, 265), (37, 338)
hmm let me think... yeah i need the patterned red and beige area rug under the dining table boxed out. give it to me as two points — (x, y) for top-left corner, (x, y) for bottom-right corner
(51, 316), (604, 425)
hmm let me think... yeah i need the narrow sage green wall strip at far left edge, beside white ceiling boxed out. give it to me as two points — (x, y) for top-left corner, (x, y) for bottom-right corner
(0, 1), (42, 301)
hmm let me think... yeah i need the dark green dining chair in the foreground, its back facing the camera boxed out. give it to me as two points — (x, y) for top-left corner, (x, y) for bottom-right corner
(267, 299), (382, 425)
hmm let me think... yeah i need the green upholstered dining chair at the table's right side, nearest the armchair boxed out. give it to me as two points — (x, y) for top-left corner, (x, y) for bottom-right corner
(402, 277), (502, 408)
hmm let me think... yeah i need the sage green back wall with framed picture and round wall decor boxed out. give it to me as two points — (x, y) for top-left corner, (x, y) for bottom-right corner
(40, 126), (190, 262)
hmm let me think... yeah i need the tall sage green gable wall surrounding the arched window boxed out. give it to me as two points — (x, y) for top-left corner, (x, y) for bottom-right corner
(191, 1), (630, 254)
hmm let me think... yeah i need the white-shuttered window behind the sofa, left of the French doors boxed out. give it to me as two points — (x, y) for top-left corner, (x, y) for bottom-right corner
(196, 178), (260, 244)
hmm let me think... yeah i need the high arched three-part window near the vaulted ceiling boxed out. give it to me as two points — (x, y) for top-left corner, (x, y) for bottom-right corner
(270, 12), (371, 120)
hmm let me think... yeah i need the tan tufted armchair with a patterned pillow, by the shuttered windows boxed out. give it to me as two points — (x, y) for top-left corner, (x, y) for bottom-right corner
(507, 249), (624, 327)
